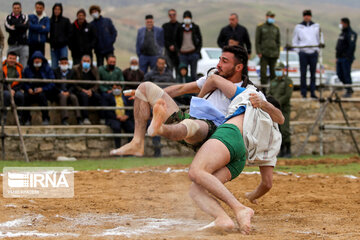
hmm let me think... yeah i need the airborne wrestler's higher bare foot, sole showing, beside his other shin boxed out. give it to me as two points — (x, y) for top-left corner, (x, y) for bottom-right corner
(147, 98), (166, 137)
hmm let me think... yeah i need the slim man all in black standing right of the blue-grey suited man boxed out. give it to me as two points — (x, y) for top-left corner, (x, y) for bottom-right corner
(162, 9), (181, 71)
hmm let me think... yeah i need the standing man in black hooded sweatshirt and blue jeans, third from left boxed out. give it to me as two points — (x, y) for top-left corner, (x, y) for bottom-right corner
(50, 3), (71, 69)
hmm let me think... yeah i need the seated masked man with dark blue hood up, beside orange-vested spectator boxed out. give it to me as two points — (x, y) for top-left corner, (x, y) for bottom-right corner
(23, 51), (55, 125)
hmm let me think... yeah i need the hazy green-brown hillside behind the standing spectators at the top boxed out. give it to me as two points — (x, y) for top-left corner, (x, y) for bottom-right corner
(0, 0), (360, 68)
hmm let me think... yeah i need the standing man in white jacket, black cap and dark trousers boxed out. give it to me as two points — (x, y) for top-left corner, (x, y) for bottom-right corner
(292, 10), (325, 99)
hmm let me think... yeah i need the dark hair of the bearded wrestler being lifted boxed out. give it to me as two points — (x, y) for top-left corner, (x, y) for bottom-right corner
(223, 46), (254, 87)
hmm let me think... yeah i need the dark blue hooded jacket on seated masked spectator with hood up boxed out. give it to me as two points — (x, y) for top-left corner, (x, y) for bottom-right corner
(23, 51), (55, 92)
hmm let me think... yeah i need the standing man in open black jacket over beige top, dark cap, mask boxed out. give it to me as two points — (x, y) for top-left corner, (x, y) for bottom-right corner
(176, 10), (202, 81)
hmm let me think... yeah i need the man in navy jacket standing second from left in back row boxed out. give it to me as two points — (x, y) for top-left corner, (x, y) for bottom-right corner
(29, 1), (50, 56)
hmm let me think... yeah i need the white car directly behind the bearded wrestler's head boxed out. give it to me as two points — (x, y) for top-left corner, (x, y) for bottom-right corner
(197, 48), (258, 78)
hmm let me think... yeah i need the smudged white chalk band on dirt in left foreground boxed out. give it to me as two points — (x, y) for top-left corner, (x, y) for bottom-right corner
(0, 213), (207, 238)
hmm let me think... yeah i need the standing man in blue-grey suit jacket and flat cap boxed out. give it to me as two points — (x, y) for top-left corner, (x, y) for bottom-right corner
(136, 15), (164, 73)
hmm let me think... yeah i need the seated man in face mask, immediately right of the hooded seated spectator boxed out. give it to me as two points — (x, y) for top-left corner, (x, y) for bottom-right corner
(54, 57), (82, 125)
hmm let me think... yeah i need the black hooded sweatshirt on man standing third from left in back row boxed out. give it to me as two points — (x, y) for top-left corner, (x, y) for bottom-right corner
(50, 3), (71, 48)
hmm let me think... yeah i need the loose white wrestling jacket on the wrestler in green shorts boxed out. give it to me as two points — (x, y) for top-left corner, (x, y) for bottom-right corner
(226, 85), (282, 166)
